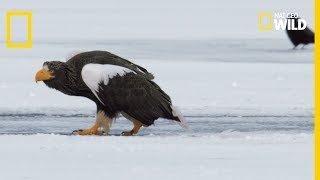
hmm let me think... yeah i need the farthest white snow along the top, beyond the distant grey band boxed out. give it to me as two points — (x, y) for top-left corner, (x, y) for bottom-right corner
(0, 0), (314, 39)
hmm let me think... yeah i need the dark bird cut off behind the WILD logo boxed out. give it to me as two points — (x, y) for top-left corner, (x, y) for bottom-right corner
(286, 18), (314, 49)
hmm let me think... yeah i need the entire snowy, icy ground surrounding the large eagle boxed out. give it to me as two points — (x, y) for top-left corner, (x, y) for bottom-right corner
(0, 0), (314, 180)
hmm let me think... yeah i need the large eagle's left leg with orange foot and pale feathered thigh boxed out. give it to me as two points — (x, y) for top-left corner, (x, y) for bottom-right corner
(73, 111), (112, 136)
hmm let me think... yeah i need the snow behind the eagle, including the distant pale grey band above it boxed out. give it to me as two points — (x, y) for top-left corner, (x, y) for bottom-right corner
(0, 40), (313, 116)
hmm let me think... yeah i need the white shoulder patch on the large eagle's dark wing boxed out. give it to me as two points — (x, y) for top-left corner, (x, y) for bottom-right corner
(81, 64), (135, 104)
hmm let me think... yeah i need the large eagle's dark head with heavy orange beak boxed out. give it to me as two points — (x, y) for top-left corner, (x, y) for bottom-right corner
(35, 61), (74, 90)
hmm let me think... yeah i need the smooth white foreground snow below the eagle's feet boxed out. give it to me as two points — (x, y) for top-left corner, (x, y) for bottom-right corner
(0, 132), (313, 180)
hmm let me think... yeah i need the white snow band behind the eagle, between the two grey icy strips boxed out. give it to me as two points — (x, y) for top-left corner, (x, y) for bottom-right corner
(0, 55), (314, 115)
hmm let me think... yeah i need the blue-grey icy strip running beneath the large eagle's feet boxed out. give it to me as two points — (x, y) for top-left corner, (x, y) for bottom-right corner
(0, 112), (313, 136)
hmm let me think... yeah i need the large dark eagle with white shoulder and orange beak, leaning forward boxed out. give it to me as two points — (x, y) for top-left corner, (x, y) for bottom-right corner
(35, 51), (188, 136)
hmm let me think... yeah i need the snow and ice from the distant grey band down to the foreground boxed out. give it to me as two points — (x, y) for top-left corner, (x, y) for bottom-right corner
(0, 39), (314, 180)
